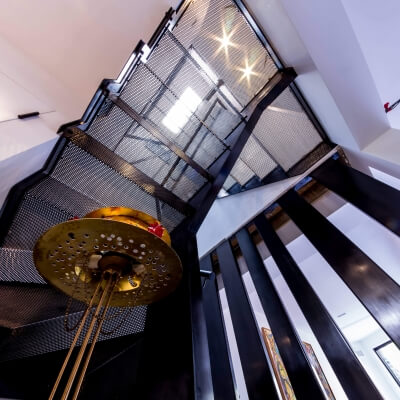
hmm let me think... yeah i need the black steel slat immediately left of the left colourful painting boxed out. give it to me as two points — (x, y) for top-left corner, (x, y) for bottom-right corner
(217, 241), (278, 400)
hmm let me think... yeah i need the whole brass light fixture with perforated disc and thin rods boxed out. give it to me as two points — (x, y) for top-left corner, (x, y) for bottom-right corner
(33, 207), (182, 400)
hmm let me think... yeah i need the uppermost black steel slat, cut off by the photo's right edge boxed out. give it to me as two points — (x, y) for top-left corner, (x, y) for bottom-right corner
(311, 159), (400, 235)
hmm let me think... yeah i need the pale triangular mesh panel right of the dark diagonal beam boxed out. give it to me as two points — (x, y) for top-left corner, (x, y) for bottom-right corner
(224, 88), (324, 190)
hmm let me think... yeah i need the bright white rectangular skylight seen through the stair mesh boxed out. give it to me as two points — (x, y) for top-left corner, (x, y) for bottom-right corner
(162, 87), (201, 134)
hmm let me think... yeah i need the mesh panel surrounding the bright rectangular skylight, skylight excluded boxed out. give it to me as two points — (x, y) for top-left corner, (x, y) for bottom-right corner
(121, 32), (234, 168)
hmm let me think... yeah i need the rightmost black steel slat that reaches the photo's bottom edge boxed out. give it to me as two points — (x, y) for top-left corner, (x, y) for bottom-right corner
(254, 214), (382, 400)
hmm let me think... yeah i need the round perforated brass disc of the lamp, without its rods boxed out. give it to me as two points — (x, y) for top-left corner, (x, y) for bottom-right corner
(33, 218), (182, 307)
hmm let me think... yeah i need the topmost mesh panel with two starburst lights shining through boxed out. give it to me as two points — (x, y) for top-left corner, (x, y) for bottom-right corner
(173, 0), (277, 106)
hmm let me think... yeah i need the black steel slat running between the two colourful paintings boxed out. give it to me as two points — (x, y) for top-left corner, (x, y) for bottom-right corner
(236, 228), (325, 400)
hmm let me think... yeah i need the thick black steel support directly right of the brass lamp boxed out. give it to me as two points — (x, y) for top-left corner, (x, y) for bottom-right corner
(137, 232), (214, 400)
